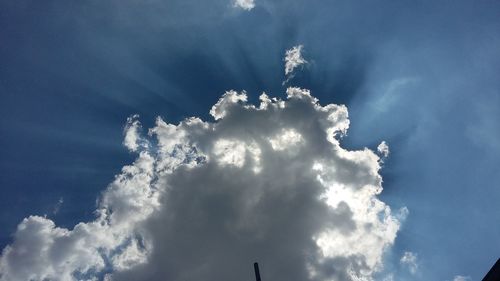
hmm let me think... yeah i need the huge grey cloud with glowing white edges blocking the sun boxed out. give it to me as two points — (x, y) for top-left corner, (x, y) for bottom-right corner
(0, 88), (403, 281)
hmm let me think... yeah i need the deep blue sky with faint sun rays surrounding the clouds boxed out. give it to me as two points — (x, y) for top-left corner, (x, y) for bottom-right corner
(0, 0), (500, 281)
